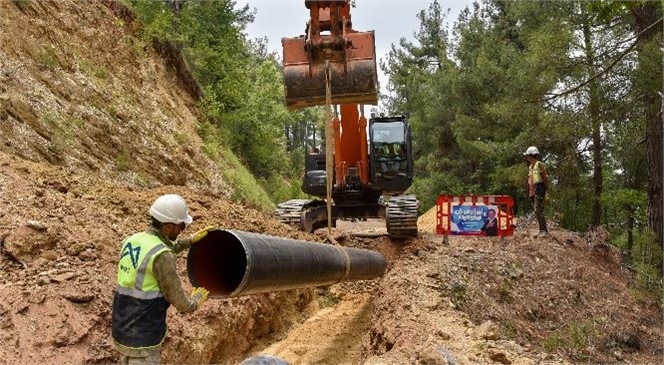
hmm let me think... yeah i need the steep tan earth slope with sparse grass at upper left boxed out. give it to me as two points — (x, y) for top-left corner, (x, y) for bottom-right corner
(0, 0), (230, 194)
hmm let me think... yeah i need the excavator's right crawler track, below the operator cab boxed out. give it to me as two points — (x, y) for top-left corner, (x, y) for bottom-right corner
(385, 195), (419, 238)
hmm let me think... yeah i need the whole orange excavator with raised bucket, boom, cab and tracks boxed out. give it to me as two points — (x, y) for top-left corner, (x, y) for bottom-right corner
(276, 0), (419, 238)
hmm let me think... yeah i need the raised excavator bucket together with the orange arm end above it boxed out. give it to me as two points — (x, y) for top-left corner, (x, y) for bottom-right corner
(281, 0), (378, 110)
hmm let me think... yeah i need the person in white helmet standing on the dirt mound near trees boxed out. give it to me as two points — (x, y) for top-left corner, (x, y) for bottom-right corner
(523, 146), (549, 237)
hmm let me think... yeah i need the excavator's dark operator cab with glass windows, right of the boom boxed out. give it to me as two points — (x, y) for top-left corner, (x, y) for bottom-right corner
(369, 117), (413, 194)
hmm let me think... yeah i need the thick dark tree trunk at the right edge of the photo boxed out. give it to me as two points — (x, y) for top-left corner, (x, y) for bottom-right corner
(631, 2), (664, 256)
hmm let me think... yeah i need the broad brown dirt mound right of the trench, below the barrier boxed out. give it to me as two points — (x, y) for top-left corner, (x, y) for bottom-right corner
(365, 226), (664, 364)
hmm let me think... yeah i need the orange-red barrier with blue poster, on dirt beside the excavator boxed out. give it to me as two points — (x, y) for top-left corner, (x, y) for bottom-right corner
(436, 195), (514, 236)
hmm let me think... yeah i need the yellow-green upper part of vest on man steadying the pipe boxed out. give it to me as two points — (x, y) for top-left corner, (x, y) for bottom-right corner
(116, 232), (170, 299)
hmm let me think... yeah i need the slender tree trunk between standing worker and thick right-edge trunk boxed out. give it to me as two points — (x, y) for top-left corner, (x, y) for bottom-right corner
(583, 13), (603, 229)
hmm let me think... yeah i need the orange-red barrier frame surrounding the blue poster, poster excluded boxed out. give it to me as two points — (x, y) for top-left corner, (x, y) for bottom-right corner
(436, 195), (514, 236)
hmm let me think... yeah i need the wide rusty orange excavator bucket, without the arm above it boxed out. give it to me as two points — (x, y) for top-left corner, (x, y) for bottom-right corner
(281, 31), (378, 110)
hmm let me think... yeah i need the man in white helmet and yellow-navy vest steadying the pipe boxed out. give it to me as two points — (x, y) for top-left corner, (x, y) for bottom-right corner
(112, 194), (213, 364)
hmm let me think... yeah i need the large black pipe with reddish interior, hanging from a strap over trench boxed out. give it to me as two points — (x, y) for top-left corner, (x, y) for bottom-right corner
(187, 229), (387, 297)
